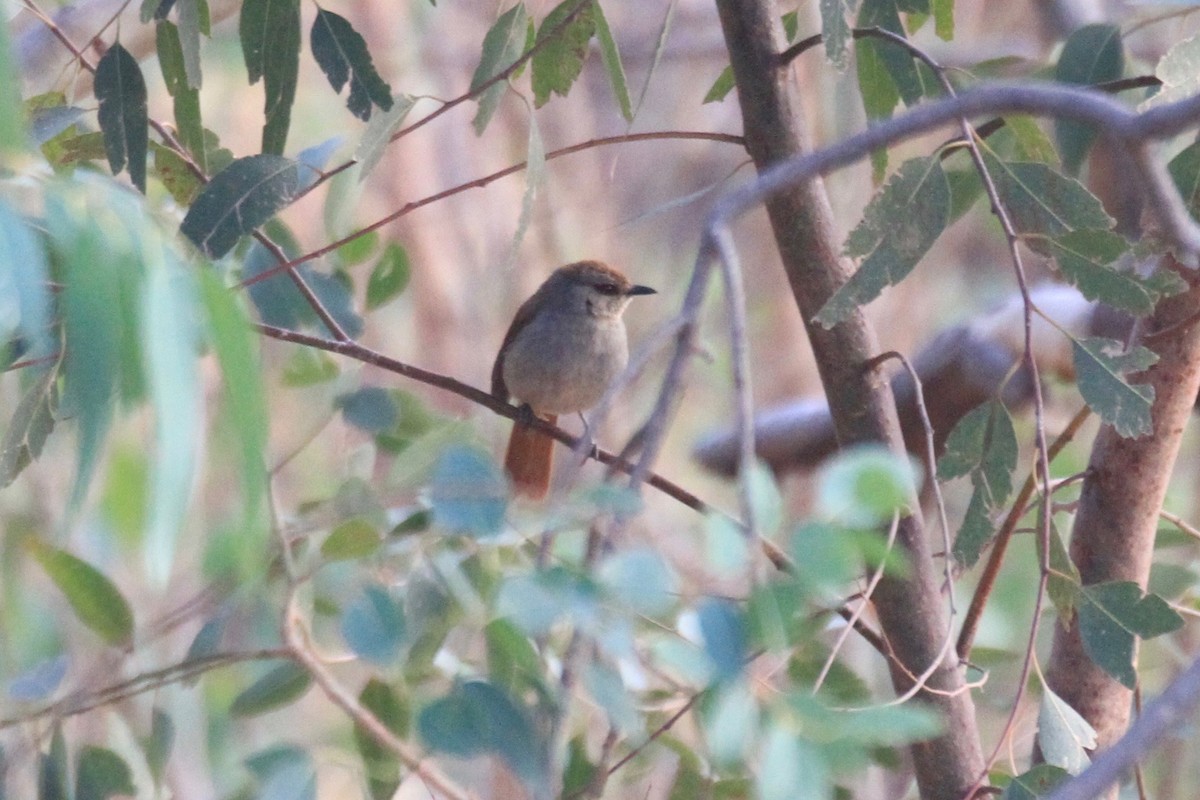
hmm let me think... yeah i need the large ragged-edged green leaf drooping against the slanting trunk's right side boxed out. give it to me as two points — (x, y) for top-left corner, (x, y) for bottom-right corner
(815, 156), (950, 327)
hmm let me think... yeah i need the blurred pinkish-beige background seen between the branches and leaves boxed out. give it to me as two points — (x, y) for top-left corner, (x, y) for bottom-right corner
(7, 0), (1200, 798)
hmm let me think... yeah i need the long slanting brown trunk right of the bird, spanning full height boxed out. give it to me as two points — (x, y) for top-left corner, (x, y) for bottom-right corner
(716, 0), (983, 800)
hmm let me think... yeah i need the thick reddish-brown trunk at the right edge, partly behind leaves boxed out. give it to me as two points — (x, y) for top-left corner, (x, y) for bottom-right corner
(1046, 261), (1200, 777)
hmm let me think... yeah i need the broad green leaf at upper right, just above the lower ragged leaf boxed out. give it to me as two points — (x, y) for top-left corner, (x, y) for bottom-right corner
(984, 149), (1112, 237)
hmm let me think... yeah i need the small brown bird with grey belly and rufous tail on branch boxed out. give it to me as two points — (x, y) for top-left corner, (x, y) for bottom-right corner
(492, 261), (655, 499)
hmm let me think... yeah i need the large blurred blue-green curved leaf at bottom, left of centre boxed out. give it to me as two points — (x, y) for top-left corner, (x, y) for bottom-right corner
(416, 680), (544, 780)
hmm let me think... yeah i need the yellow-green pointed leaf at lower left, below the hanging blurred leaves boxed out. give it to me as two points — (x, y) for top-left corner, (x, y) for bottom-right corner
(28, 539), (133, 646)
